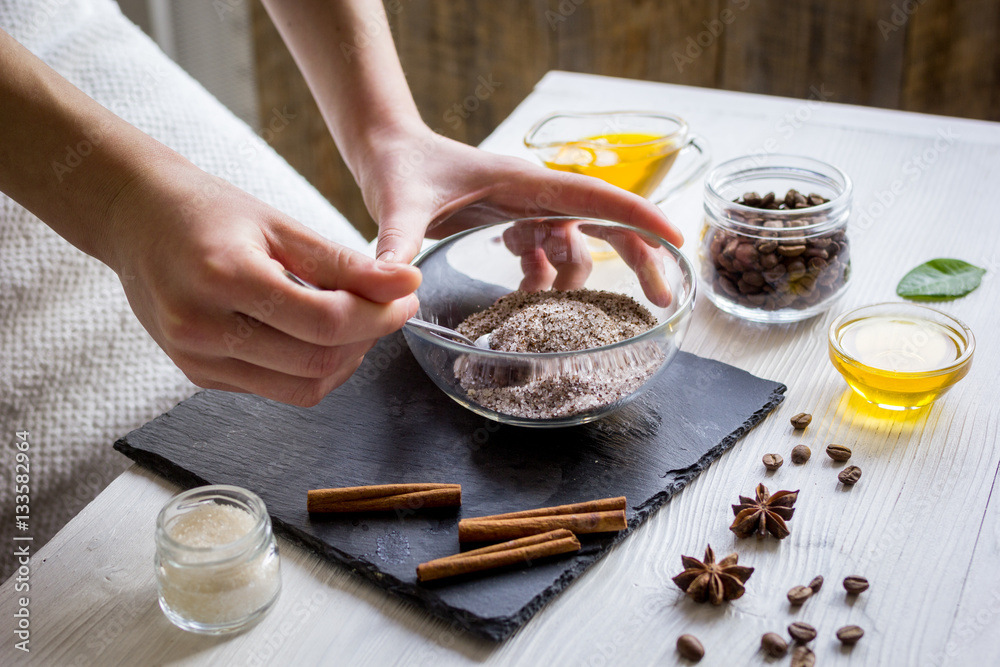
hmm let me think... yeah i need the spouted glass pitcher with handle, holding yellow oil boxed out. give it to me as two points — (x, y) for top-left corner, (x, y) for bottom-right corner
(524, 111), (710, 204)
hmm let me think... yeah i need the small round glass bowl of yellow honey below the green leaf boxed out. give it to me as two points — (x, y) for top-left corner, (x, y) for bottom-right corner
(829, 302), (976, 410)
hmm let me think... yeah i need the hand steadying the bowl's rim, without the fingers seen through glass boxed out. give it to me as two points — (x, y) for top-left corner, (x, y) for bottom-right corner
(357, 124), (684, 262)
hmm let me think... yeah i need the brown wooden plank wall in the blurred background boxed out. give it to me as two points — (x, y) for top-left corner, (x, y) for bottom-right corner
(254, 0), (1000, 238)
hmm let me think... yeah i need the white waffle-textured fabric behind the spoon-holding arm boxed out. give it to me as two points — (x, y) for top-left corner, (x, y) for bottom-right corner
(0, 0), (364, 580)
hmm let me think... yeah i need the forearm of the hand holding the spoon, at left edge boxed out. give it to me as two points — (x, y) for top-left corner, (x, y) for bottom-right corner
(0, 30), (183, 268)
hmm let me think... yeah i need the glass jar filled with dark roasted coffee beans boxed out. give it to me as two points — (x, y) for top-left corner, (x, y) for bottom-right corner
(699, 154), (852, 322)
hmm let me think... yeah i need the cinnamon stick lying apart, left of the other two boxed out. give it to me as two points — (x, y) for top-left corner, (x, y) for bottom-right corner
(306, 484), (462, 512)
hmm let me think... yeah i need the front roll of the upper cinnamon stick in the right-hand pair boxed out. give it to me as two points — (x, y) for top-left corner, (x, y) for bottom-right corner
(458, 510), (628, 542)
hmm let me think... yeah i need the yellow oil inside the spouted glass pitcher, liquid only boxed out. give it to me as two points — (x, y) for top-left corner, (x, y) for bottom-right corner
(545, 133), (680, 197)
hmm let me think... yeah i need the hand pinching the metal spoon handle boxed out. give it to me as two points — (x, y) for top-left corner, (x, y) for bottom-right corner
(104, 163), (420, 406)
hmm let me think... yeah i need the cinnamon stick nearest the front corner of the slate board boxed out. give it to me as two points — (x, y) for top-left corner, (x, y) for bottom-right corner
(417, 530), (580, 581)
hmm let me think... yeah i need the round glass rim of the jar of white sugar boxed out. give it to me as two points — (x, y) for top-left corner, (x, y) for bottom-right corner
(156, 484), (271, 565)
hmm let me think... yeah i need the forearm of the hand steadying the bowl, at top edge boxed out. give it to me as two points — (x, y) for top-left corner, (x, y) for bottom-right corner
(264, 0), (423, 181)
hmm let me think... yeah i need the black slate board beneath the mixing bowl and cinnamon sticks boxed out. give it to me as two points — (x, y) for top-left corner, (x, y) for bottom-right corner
(115, 334), (785, 640)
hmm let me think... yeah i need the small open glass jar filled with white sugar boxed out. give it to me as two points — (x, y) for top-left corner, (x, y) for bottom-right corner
(156, 485), (281, 634)
